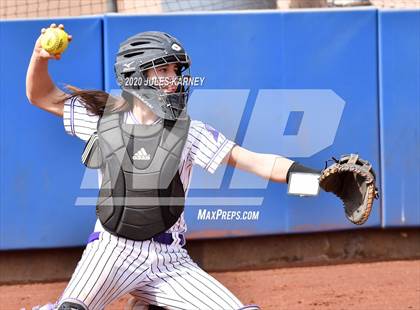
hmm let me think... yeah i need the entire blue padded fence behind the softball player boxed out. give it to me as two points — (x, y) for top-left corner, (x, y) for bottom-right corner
(0, 9), (420, 249)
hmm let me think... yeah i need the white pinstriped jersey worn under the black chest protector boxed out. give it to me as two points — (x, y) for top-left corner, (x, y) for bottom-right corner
(63, 97), (235, 233)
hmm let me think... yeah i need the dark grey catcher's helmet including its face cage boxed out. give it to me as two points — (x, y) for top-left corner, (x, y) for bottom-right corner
(114, 31), (191, 120)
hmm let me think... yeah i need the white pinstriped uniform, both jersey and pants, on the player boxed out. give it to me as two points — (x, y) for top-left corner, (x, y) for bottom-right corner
(35, 98), (253, 310)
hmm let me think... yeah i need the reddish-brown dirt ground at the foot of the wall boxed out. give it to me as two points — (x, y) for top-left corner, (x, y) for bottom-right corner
(0, 260), (420, 310)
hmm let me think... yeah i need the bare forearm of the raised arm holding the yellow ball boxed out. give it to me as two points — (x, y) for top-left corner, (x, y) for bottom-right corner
(26, 51), (56, 105)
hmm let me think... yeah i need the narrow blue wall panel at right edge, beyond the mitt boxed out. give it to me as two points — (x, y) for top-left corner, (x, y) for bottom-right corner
(378, 10), (420, 227)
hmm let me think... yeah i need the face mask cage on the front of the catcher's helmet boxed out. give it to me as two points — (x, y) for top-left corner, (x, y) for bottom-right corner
(122, 54), (191, 120)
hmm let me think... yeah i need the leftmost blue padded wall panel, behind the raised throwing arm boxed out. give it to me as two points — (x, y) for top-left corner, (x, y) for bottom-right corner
(0, 17), (103, 249)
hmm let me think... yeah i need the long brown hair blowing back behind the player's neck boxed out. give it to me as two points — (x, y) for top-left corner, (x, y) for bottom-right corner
(65, 85), (133, 116)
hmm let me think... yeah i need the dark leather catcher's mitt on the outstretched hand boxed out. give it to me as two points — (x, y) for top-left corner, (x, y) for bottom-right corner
(319, 154), (379, 225)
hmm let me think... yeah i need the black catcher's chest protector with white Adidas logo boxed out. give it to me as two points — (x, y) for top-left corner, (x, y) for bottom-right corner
(91, 113), (190, 240)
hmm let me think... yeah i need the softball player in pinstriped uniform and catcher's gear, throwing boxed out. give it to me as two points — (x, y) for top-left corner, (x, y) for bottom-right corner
(26, 24), (316, 310)
